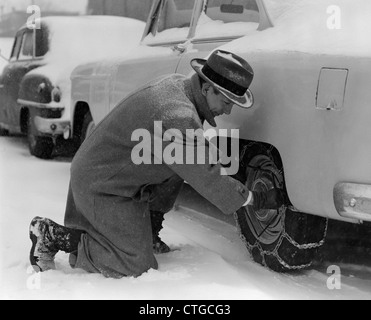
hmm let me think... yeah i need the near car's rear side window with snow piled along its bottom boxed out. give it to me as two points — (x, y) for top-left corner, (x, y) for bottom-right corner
(195, 0), (259, 39)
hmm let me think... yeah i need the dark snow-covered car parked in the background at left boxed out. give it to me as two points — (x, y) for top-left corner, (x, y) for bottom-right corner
(0, 16), (145, 159)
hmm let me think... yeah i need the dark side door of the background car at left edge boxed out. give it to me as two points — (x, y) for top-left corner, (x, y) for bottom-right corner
(0, 28), (42, 132)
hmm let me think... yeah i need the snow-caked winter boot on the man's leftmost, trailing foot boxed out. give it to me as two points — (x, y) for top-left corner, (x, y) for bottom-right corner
(30, 217), (82, 272)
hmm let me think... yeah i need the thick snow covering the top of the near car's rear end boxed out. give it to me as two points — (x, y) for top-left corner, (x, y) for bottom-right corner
(223, 0), (371, 56)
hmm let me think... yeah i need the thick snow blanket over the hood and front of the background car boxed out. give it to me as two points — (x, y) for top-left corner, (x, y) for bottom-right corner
(25, 16), (145, 105)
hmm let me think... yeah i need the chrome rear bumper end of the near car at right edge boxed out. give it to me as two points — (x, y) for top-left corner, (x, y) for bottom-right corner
(334, 182), (371, 221)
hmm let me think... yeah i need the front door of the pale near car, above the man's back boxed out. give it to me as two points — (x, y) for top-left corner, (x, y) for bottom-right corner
(110, 0), (203, 109)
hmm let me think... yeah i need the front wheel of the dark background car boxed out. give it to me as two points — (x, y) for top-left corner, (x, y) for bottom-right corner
(27, 116), (54, 159)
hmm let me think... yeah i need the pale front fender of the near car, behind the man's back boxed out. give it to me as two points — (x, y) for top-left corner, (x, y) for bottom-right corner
(71, 48), (180, 124)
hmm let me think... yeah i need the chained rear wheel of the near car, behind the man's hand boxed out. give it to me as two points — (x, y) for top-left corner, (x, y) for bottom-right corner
(235, 144), (328, 272)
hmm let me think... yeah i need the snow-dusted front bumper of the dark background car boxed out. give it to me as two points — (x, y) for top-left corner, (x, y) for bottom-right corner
(34, 116), (71, 139)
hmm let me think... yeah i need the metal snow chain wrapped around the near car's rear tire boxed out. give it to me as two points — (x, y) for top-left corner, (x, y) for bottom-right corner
(234, 142), (328, 271)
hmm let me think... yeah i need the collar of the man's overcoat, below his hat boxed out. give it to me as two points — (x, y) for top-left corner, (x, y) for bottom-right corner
(185, 74), (216, 127)
